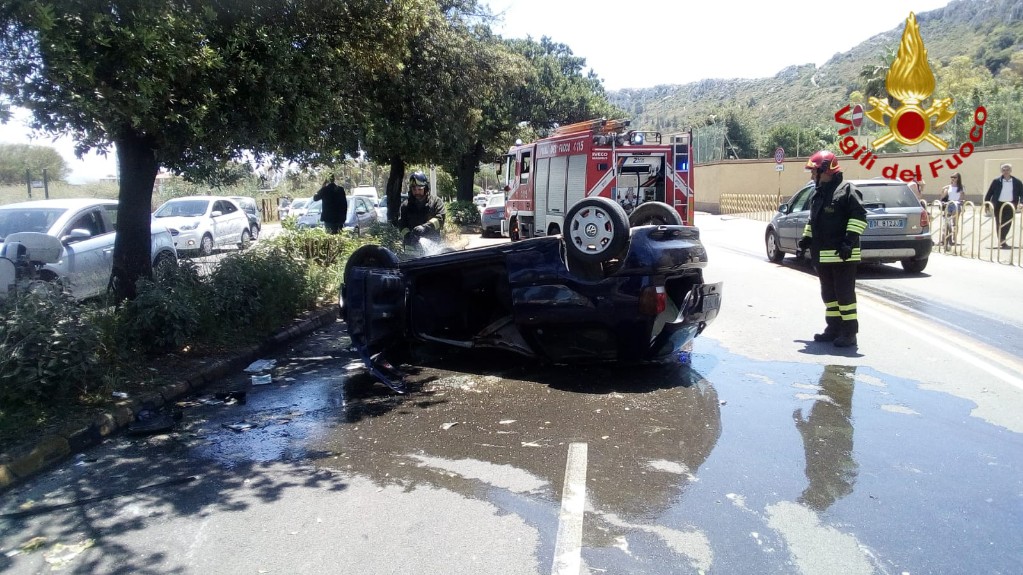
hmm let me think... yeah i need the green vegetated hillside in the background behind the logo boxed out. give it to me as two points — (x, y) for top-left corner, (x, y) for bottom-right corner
(609, 0), (1023, 162)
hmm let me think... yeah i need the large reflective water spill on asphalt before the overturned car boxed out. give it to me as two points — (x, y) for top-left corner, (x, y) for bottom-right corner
(163, 329), (1023, 573)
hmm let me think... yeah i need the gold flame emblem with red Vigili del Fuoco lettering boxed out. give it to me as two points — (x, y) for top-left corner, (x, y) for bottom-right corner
(835, 12), (987, 181)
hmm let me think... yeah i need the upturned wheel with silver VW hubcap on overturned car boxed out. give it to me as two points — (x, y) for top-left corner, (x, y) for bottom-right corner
(563, 196), (629, 263)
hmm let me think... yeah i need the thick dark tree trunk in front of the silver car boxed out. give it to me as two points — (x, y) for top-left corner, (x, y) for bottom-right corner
(110, 130), (160, 301)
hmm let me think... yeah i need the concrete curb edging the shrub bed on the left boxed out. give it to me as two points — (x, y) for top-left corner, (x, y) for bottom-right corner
(0, 306), (339, 492)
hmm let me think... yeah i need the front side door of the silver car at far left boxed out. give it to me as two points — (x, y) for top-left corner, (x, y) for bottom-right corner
(59, 207), (115, 300)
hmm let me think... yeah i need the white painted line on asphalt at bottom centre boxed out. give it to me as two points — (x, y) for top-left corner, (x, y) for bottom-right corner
(550, 443), (586, 575)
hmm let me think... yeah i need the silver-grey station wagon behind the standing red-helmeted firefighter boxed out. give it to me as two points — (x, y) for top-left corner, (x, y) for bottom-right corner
(764, 178), (932, 273)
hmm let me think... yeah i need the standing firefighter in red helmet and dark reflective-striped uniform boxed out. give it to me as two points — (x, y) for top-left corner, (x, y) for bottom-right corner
(799, 151), (866, 348)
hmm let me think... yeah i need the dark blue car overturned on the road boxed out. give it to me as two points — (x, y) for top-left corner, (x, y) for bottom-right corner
(340, 197), (721, 391)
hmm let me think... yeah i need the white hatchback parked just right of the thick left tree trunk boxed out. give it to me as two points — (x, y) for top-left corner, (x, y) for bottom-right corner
(152, 195), (252, 256)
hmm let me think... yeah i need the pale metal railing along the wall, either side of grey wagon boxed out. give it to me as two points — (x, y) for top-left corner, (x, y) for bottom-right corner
(719, 193), (1023, 267)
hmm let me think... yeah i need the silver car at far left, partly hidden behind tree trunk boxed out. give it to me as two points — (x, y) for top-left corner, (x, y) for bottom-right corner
(0, 197), (178, 300)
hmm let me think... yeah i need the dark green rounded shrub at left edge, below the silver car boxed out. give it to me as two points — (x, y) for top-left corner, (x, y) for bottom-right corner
(0, 290), (102, 404)
